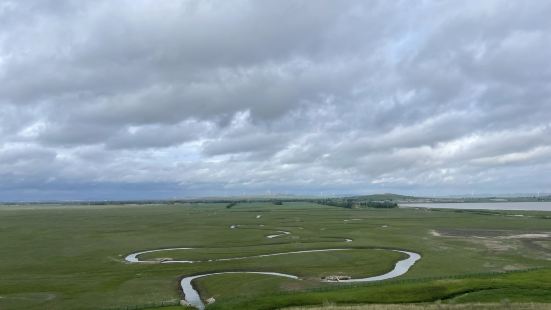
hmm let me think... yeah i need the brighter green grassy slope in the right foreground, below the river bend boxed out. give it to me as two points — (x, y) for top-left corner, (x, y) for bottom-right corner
(212, 269), (551, 309)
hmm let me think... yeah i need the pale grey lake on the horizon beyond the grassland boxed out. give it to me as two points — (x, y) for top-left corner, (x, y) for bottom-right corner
(400, 202), (551, 211)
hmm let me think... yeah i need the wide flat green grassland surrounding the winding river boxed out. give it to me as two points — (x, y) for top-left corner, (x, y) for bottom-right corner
(0, 202), (551, 310)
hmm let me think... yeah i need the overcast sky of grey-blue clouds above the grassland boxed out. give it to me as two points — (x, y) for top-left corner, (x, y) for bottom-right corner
(0, 0), (551, 201)
